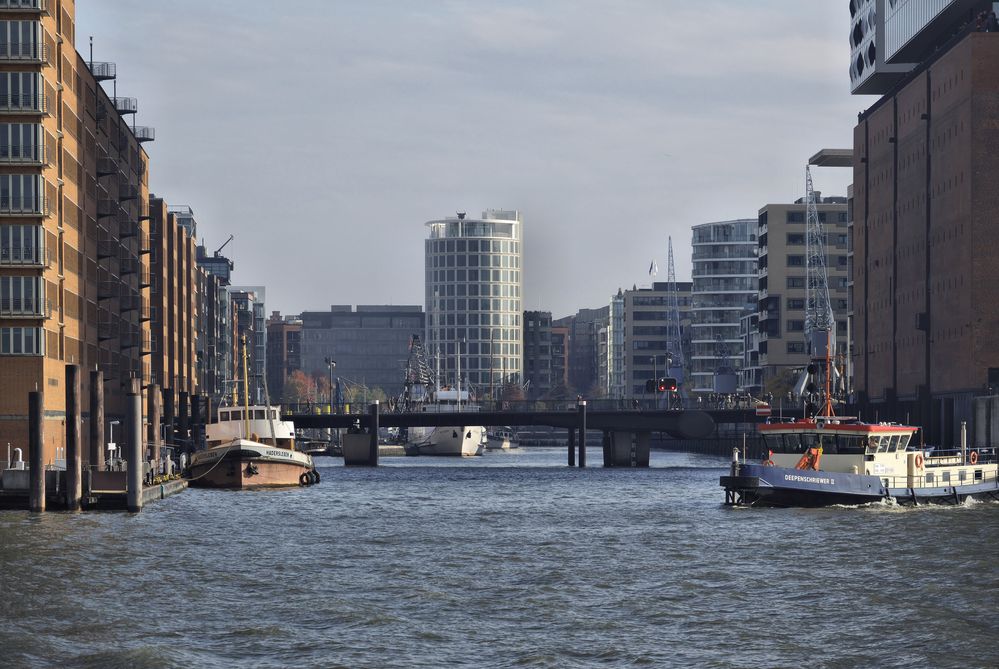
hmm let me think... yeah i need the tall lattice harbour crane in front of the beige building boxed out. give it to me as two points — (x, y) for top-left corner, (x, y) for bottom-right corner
(796, 165), (836, 415)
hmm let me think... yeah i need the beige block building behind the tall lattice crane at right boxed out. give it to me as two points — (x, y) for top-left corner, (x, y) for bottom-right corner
(747, 192), (849, 395)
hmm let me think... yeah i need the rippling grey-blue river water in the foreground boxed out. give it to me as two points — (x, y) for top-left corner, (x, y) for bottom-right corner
(0, 449), (999, 668)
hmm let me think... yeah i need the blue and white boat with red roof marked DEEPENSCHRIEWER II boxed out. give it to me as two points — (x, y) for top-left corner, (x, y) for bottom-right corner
(720, 416), (999, 506)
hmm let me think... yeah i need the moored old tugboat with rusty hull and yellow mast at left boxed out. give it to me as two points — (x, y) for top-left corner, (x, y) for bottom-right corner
(188, 337), (319, 489)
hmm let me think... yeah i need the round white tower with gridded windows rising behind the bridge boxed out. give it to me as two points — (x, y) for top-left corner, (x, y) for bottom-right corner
(425, 209), (524, 394)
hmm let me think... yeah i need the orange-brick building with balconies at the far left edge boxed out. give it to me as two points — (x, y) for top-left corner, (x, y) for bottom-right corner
(0, 0), (153, 466)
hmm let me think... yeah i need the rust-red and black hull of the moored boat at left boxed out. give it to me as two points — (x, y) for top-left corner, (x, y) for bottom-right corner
(189, 443), (315, 490)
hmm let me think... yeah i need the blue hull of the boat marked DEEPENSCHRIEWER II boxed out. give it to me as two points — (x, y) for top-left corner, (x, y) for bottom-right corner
(719, 464), (999, 507)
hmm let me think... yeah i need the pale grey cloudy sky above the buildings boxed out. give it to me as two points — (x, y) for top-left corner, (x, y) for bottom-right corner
(76, 0), (873, 318)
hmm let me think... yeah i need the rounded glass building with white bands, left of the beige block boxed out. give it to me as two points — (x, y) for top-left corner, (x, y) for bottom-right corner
(687, 218), (759, 393)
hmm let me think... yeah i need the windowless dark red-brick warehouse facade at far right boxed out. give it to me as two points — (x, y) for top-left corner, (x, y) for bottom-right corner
(853, 32), (999, 445)
